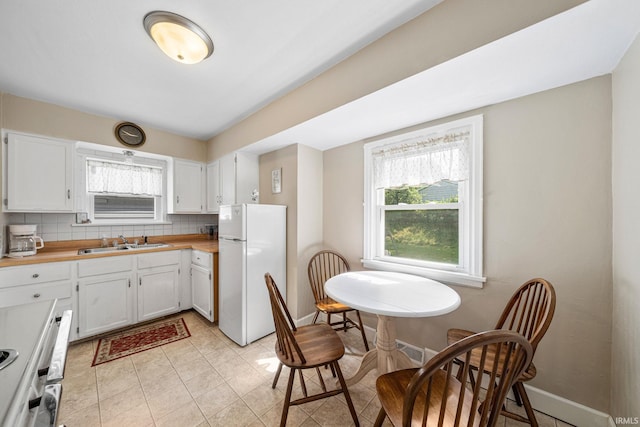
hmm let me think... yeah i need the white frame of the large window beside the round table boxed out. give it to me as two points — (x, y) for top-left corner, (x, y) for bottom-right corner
(362, 115), (486, 288)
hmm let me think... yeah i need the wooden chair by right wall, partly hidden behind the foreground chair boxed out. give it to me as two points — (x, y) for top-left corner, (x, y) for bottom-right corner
(447, 279), (556, 427)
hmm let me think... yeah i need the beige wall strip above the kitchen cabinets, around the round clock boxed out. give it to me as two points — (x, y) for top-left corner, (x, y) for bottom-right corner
(0, 93), (207, 161)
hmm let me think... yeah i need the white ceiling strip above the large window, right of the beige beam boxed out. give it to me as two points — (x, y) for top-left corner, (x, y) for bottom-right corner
(246, 0), (640, 153)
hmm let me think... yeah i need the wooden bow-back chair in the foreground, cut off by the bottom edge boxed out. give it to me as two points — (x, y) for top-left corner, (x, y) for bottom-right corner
(374, 330), (533, 427)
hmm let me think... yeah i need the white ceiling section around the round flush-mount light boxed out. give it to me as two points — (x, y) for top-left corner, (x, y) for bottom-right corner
(0, 0), (442, 140)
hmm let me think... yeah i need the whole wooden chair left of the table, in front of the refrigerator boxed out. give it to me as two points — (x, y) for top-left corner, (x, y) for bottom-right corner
(264, 273), (360, 427)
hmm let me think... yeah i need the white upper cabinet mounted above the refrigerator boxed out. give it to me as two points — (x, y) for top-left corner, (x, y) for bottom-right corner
(207, 152), (259, 213)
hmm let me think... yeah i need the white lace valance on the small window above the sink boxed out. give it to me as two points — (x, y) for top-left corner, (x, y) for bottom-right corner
(87, 159), (162, 196)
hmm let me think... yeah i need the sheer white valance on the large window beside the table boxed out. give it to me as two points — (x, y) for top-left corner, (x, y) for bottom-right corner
(371, 126), (472, 189)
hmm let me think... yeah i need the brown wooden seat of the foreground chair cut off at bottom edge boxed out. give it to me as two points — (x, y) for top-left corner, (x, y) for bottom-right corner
(376, 369), (480, 427)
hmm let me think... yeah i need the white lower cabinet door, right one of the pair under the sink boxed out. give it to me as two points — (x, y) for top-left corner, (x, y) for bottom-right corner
(138, 265), (180, 322)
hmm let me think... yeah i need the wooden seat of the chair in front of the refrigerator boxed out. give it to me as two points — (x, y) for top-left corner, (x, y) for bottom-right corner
(276, 323), (344, 369)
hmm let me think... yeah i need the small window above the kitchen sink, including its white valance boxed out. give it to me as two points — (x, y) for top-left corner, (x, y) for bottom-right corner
(86, 158), (163, 223)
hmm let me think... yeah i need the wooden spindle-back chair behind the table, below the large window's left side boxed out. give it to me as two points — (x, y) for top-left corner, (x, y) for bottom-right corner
(307, 250), (369, 351)
